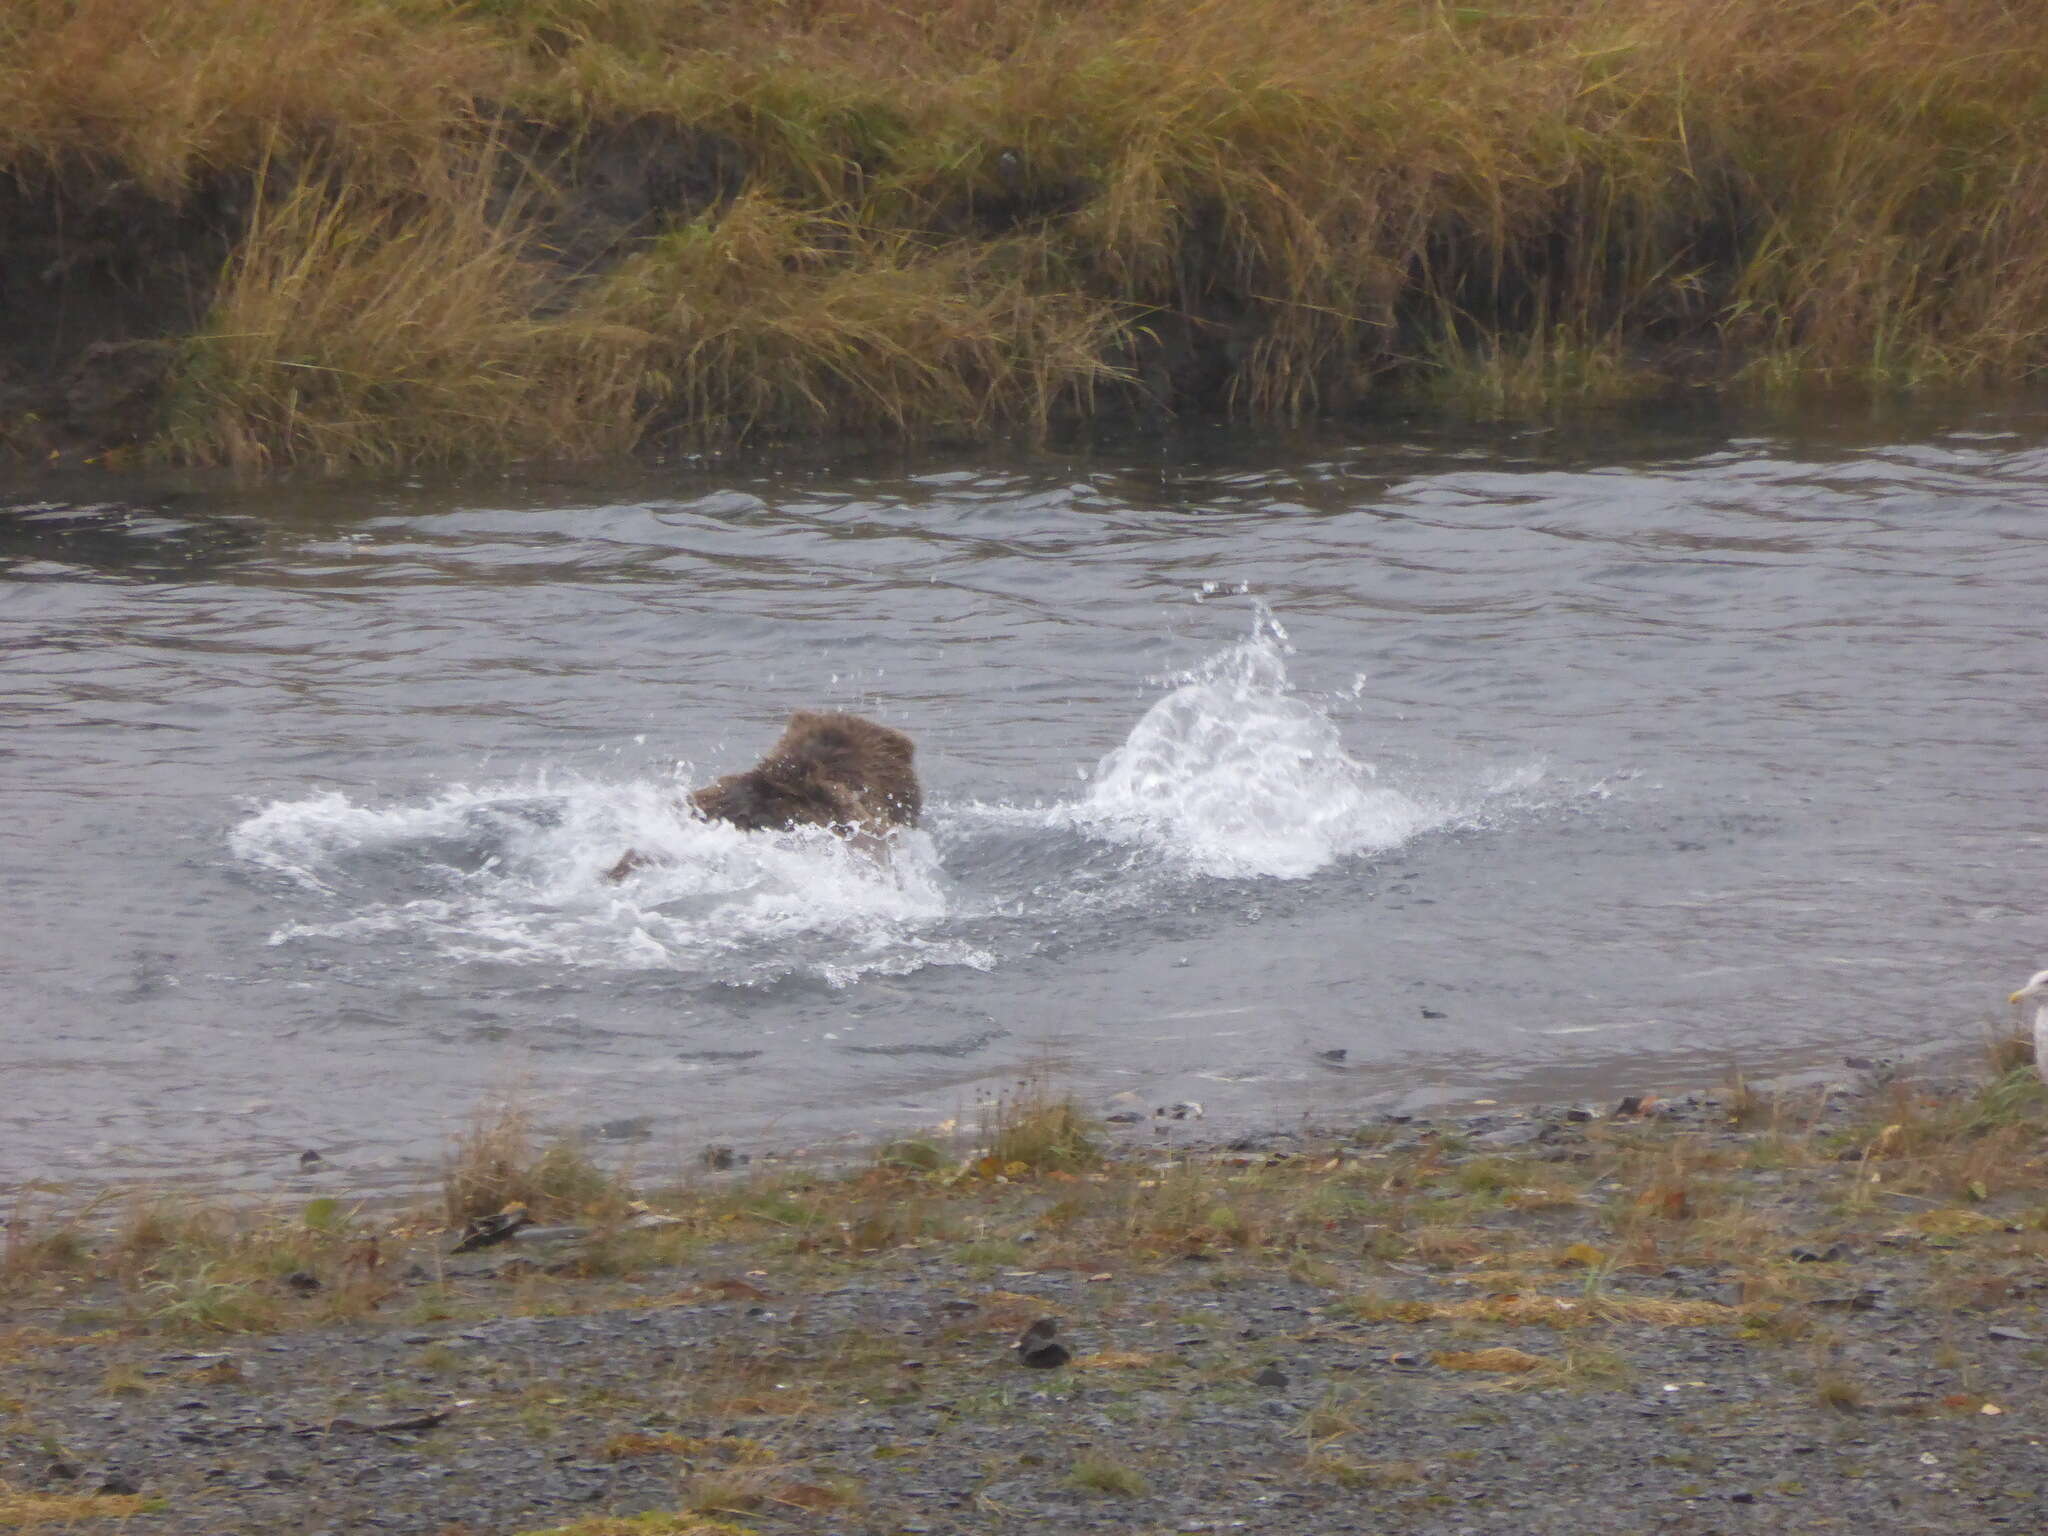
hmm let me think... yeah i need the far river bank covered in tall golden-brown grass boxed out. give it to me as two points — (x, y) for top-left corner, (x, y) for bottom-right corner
(0, 0), (2048, 465)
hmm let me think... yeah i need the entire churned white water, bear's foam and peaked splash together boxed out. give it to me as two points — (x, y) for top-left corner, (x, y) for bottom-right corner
(231, 608), (1523, 987)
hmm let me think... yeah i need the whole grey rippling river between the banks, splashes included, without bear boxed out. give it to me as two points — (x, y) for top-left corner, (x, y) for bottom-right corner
(0, 410), (2048, 1186)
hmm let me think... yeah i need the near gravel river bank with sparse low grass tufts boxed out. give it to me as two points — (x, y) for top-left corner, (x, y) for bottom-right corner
(0, 1047), (2048, 1536)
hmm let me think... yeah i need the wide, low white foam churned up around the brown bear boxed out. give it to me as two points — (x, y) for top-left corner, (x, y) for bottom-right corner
(231, 776), (991, 985)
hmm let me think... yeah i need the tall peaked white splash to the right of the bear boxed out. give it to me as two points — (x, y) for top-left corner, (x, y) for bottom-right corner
(1071, 606), (1452, 879)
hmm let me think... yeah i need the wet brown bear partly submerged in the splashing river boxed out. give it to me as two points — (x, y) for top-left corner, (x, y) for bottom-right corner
(606, 709), (924, 881)
